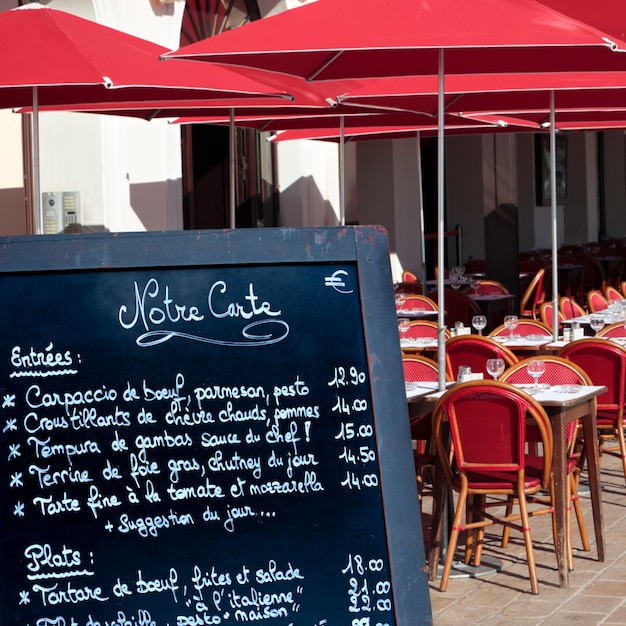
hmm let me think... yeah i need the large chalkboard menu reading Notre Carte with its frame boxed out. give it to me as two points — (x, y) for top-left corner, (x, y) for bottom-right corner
(0, 227), (431, 626)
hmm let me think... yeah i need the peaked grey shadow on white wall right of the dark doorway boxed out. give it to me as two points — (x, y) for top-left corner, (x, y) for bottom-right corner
(279, 176), (339, 227)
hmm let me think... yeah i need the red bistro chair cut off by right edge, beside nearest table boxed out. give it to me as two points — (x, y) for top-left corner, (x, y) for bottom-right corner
(557, 337), (626, 480)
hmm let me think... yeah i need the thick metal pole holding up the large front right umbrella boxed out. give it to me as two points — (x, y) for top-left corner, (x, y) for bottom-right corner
(437, 48), (446, 391)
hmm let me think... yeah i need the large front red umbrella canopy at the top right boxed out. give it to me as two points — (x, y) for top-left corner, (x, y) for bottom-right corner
(164, 0), (626, 80)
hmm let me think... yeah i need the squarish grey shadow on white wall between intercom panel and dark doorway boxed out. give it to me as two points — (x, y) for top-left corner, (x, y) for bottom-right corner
(130, 180), (182, 230)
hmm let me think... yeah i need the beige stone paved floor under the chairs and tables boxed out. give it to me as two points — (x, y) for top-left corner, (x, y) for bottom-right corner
(423, 444), (626, 626)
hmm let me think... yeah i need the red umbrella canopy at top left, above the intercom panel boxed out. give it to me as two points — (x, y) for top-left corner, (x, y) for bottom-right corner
(0, 4), (289, 108)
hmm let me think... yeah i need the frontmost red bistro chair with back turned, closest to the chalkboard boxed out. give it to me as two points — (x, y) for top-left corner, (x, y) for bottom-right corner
(433, 380), (552, 593)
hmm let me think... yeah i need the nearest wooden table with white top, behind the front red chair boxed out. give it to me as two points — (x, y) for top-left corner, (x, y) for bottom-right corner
(407, 383), (606, 588)
